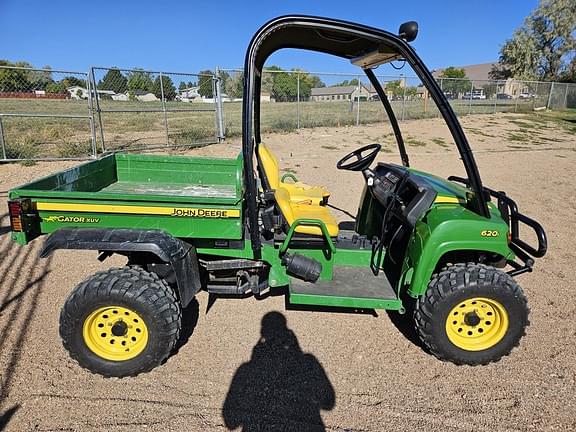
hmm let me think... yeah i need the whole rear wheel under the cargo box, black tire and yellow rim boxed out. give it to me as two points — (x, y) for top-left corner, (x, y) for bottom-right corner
(60, 267), (181, 377)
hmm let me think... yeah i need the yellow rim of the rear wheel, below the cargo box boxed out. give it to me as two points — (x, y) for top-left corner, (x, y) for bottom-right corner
(82, 306), (148, 361)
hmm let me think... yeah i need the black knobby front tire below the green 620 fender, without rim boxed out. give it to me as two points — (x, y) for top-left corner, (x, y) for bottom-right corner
(414, 263), (529, 366)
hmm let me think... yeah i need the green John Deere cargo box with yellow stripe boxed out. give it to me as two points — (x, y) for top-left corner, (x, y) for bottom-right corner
(9, 154), (243, 243)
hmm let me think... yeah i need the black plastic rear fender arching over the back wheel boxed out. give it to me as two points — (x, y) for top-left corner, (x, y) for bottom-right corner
(40, 228), (201, 308)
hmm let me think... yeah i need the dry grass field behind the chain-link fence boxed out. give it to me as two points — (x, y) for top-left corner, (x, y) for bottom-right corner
(0, 95), (545, 159)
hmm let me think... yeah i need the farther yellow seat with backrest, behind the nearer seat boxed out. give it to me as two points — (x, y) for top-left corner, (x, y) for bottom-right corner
(258, 143), (330, 206)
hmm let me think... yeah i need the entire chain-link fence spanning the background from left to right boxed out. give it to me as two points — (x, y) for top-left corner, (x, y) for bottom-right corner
(0, 62), (576, 160)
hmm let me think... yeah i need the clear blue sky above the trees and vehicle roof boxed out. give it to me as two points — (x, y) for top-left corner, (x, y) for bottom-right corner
(0, 0), (538, 74)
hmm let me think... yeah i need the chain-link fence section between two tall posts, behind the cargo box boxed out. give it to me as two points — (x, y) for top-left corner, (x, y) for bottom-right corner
(90, 67), (223, 151)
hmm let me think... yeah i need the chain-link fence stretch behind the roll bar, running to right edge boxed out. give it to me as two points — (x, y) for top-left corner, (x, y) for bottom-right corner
(218, 69), (576, 137)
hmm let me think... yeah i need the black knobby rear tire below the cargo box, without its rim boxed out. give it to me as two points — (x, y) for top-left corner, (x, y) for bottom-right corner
(60, 267), (181, 377)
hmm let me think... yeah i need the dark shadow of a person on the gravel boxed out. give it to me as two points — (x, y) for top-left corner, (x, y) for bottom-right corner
(222, 312), (336, 432)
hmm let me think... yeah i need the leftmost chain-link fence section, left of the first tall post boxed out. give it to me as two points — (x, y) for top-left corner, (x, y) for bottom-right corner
(0, 66), (96, 160)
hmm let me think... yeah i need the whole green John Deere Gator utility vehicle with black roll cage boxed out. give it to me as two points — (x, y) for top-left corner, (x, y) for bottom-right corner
(9, 16), (547, 377)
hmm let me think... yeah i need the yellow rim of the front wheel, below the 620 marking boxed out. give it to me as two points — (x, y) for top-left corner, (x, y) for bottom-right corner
(446, 297), (509, 351)
